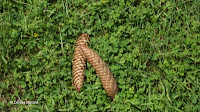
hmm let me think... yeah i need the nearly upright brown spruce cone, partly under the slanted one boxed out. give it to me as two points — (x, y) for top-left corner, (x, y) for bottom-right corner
(72, 33), (90, 91)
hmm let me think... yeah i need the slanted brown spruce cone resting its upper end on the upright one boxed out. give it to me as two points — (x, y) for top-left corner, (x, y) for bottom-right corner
(80, 46), (118, 99)
